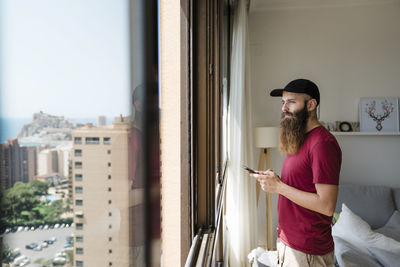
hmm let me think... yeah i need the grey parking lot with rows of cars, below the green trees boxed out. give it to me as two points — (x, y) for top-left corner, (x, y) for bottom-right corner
(3, 227), (73, 267)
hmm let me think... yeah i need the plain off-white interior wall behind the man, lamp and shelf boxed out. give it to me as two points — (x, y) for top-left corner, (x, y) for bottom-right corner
(249, 1), (400, 247)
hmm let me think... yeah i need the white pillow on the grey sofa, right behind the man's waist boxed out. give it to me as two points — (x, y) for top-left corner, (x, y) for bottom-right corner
(332, 203), (400, 254)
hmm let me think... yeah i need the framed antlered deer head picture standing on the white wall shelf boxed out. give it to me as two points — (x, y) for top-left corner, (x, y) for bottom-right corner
(360, 97), (399, 132)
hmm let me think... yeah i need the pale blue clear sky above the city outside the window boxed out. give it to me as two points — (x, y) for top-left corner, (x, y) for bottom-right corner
(0, 0), (130, 118)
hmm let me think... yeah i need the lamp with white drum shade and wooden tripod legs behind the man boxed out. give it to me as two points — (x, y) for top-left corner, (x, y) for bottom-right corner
(254, 127), (279, 250)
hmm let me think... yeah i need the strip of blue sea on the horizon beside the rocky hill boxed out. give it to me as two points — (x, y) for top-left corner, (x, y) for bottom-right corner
(0, 117), (103, 144)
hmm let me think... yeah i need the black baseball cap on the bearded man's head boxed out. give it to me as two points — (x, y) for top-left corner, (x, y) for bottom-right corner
(269, 79), (319, 106)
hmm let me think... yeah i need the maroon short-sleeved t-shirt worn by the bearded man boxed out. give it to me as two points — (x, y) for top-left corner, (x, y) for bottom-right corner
(278, 126), (342, 255)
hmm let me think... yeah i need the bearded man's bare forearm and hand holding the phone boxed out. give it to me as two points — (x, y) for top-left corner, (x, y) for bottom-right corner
(251, 170), (338, 216)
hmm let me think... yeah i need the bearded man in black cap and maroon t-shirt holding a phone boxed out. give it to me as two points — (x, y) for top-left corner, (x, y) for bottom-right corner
(251, 79), (342, 267)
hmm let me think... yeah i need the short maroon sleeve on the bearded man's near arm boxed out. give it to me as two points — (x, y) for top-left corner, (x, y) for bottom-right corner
(311, 140), (342, 185)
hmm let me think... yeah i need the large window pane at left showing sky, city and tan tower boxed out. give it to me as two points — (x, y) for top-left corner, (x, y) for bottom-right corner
(0, 0), (160, 266)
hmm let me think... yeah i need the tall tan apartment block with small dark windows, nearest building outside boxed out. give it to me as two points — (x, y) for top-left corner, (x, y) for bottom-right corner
(72, 122), (132, 267)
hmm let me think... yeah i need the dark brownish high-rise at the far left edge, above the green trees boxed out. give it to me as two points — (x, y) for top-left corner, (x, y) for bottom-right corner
(0, 138), (37, 189)
